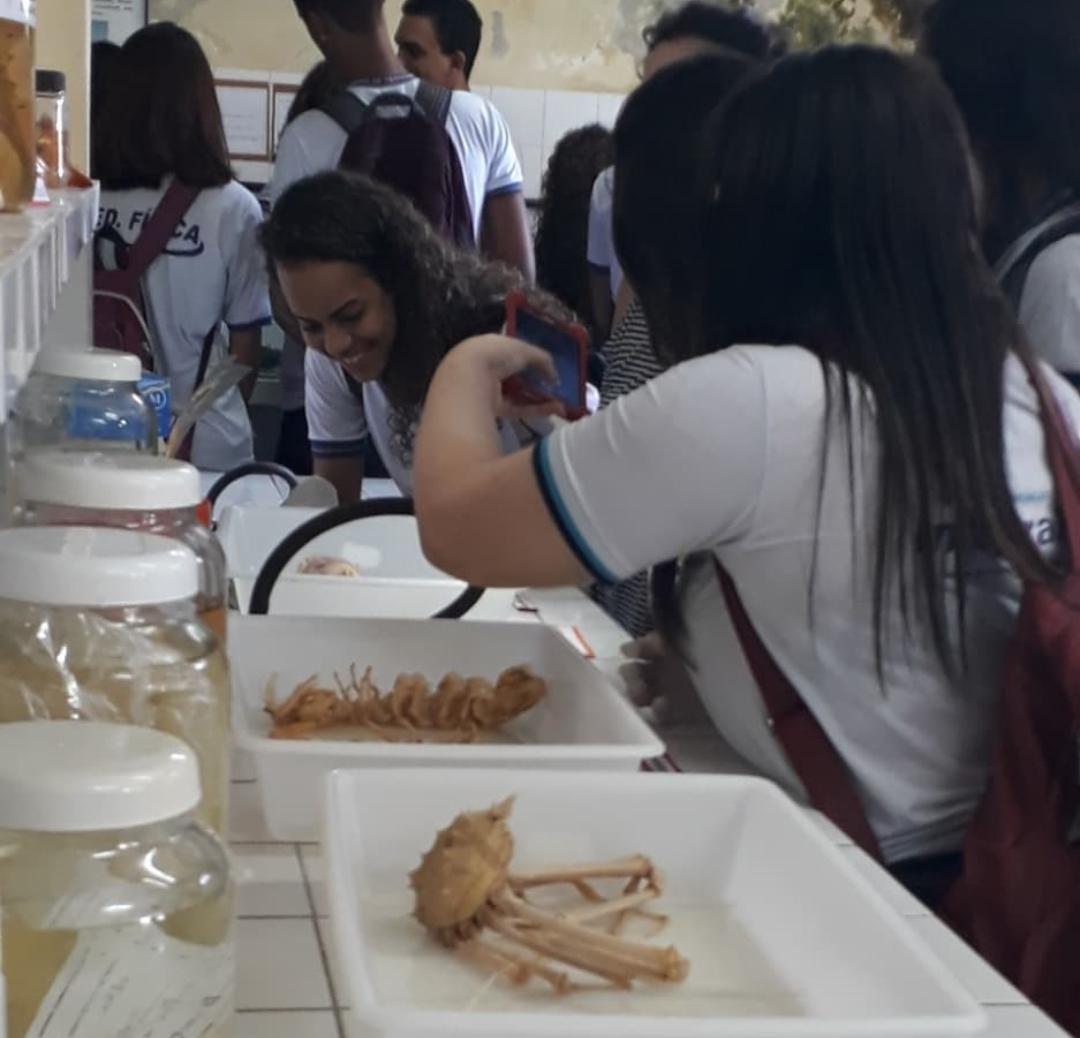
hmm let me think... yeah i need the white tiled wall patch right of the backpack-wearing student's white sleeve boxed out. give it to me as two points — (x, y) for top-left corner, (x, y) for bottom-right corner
(475, 86), (625, 199)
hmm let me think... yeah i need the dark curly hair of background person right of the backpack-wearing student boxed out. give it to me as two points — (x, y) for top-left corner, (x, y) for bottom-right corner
(536, 124), (615, 328)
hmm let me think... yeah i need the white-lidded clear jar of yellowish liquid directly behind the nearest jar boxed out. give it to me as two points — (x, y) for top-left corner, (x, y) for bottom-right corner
(0, 526), (230, 835)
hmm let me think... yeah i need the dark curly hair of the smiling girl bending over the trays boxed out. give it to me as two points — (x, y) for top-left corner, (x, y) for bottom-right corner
(262, 172), (565, 410)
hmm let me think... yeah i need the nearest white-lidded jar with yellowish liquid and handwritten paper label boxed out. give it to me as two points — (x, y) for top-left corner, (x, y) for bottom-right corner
(0, 722), (235, 1038)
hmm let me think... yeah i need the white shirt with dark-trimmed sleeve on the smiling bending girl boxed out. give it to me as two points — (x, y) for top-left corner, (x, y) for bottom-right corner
(305, 350), (535, 497)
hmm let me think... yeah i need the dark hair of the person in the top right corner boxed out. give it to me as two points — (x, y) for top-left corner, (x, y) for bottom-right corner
(922, 0), (1080, 251)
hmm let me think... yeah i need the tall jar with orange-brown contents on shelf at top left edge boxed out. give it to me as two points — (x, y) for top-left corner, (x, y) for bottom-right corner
(0, 0), (38, 213)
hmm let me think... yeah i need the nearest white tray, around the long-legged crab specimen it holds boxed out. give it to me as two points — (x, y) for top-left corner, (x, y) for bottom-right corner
(323, 769), (986, 1038)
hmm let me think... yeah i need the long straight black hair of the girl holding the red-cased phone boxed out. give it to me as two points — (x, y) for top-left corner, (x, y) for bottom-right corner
(666, 46), (1055, 673)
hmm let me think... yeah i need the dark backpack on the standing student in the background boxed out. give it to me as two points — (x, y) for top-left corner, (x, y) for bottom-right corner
(322, 82), (476, 250)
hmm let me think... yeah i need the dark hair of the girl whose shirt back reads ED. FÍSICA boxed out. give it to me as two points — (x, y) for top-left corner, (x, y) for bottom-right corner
(92, 22), (232, 191)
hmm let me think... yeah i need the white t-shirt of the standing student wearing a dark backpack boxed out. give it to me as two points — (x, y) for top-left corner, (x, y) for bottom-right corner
(267, 76), (523, 241)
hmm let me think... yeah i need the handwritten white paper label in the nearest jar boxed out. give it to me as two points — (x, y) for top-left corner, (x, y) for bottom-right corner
(27, 926), (234, 1038)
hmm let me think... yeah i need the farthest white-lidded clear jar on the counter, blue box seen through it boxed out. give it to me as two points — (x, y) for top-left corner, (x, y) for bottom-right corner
(9, 348), (158, 451)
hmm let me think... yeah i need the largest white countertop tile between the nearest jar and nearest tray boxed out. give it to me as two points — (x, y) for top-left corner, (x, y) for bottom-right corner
(237, 919), (330, 1006)
